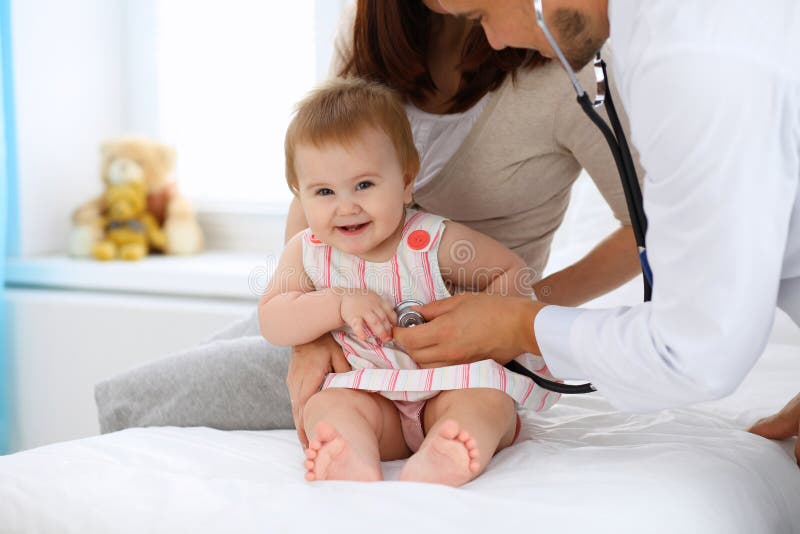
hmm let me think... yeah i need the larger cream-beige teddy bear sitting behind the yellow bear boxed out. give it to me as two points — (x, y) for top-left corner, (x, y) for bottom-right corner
(68, 137), (203, 257)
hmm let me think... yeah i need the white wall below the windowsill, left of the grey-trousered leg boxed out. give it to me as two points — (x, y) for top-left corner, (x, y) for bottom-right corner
(5, 289), (255, 452)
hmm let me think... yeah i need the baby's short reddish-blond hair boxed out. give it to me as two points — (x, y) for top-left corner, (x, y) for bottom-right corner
(284, 78), (419, 196)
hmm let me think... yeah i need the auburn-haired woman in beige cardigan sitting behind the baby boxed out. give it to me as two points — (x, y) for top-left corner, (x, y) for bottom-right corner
(286, 0), (639, 445)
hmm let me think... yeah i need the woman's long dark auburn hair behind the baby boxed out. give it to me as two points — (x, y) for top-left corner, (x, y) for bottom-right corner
(339, 0), (547, 113)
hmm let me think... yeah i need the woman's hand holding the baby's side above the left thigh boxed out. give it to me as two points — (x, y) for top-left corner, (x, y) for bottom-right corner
(286, 334), (352, 449)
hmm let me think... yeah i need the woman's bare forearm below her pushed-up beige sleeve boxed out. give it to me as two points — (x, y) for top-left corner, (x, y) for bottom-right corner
(534, 226), (641, 306)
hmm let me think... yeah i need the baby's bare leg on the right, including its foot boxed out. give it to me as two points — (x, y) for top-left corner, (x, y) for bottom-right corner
(400, 388), (517, 486)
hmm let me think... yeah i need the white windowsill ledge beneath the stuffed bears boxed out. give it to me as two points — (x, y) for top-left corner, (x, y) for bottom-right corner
(6, 251), (277, 301)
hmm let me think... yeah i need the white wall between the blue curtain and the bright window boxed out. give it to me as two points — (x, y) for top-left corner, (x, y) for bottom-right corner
(11, 0), (127, 256)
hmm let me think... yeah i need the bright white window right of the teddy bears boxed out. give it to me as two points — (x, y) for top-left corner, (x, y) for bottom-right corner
(154, 0), (348, 209)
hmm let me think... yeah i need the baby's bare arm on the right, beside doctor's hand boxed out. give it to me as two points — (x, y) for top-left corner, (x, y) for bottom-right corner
(438, 221), (534, 297)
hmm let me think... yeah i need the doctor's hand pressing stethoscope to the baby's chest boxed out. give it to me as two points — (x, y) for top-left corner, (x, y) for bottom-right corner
(393, 293), (545, 367)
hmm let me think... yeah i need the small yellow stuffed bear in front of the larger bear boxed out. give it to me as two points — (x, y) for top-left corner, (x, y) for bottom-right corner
(92, 180), (166, 260)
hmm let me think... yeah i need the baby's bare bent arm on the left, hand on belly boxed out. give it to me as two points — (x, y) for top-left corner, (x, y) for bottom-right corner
(258, 234), (397, 346)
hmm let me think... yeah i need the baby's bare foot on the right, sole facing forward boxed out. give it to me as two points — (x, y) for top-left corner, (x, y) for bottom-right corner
(400, 419), (480, 486)
